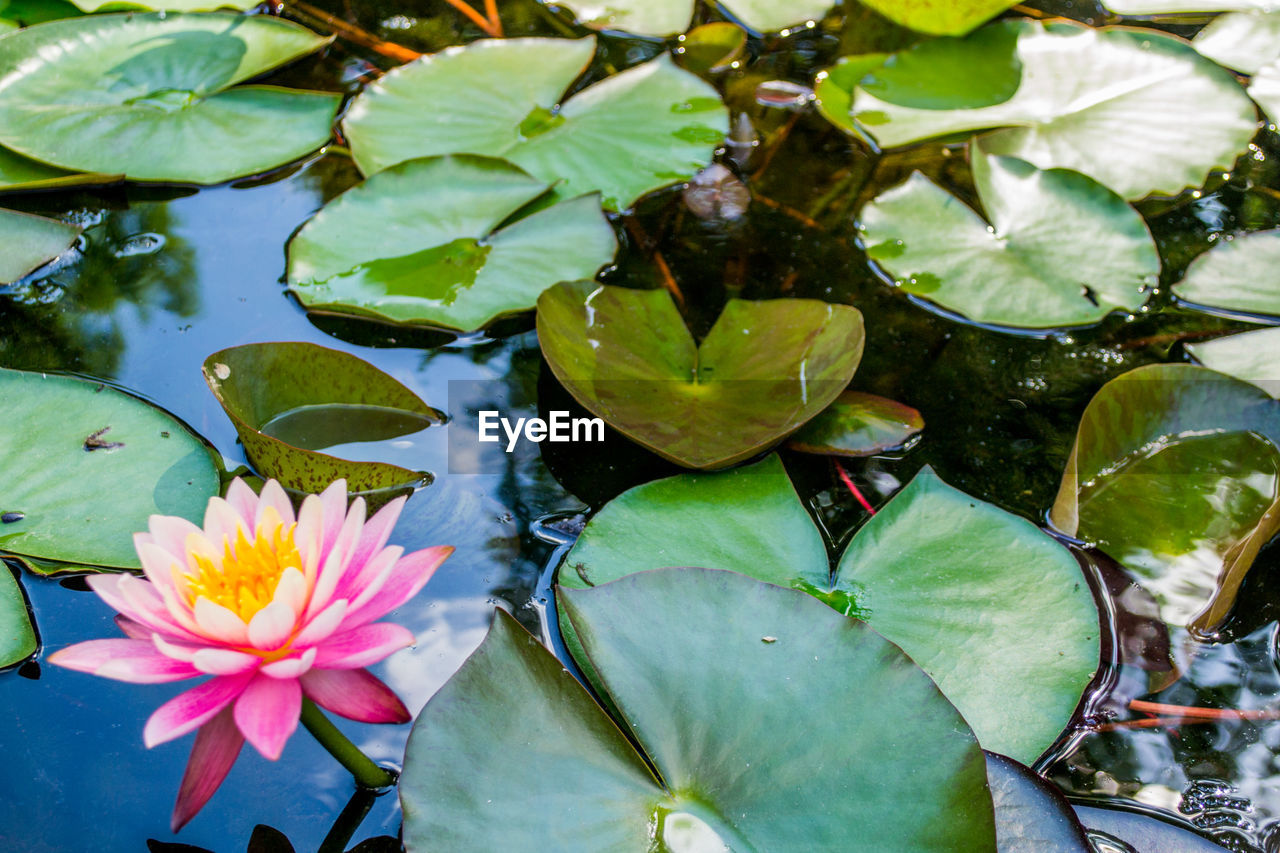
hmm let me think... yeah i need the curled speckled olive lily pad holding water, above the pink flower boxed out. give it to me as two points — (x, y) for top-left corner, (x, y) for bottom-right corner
(204, 342), (444, 493)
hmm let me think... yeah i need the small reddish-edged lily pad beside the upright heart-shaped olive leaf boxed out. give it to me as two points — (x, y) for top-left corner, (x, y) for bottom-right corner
(787, 391), (924, 456)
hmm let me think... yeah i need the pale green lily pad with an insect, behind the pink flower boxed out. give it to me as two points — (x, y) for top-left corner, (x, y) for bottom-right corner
(0, 368), (219, 569)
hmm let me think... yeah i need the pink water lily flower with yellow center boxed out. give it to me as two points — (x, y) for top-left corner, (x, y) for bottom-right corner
(49, 479), (453, 831)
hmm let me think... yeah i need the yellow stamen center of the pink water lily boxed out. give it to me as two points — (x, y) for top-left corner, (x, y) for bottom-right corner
(186, 511), (302, 622)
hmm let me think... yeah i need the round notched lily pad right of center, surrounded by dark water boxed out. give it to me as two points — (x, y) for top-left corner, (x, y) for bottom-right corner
(860, 146), (1160, 328)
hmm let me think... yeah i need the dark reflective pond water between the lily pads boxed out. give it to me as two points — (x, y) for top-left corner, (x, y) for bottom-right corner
(0, 0), (1280, 853)
